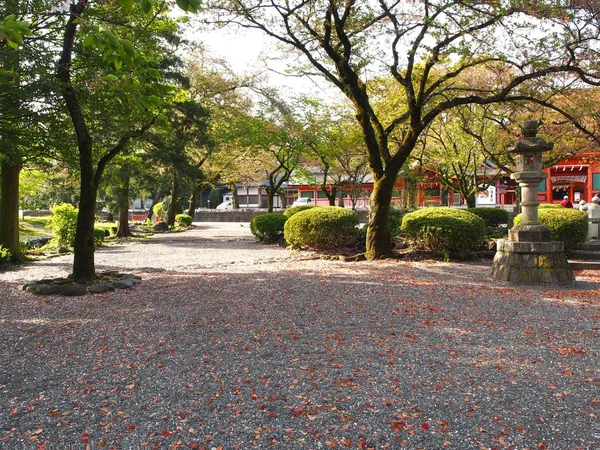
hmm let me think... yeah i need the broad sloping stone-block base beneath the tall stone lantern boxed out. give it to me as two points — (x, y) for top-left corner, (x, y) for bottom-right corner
(490, 240), (575, 285)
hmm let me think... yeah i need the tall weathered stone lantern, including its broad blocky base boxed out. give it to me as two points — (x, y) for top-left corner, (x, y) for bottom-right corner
(490, 120), (575, 284)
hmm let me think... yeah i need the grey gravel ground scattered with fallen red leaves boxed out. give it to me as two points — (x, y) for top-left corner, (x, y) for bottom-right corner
(0, 224), (600, 450)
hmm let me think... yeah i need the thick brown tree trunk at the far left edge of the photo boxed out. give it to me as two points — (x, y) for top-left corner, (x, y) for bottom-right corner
(0, 161), (26, 263)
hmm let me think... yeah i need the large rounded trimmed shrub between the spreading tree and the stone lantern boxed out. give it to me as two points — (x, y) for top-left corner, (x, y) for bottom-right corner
(401, 207), (486, 258)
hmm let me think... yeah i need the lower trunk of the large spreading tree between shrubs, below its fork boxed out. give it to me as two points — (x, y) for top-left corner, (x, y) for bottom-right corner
(365, 174), (395, 260)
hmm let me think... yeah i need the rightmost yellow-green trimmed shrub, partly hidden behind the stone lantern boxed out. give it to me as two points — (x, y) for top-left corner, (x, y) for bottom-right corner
(514, 206), (589, 250)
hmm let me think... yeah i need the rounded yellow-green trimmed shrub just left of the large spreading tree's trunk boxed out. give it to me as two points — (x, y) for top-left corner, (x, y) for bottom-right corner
(284, 206), (359, 250)
